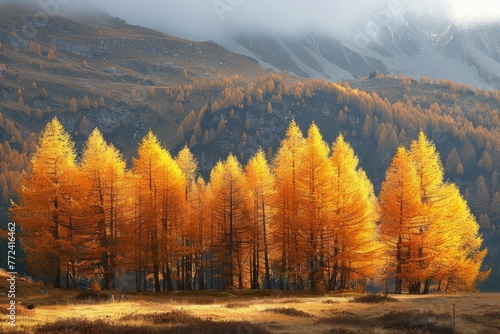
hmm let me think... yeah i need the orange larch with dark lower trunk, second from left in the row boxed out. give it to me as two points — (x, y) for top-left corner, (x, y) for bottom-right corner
(80, 129), (129, 290)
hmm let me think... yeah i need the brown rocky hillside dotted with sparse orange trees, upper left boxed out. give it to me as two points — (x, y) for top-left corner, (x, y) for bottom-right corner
(0, 5), (267, 146)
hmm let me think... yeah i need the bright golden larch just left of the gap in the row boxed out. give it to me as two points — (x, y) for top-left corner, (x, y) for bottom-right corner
(326, 135), (383, 290)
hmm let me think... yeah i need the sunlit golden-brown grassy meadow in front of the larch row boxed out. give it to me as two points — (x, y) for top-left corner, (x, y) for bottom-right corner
(0, 276), (500, 334)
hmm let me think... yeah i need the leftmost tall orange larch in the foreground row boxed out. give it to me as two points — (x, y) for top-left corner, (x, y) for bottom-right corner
(10, 118), (78, 288)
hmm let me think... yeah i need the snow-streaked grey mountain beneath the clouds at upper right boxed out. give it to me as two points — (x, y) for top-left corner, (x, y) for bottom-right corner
(217, 8), (500, 89)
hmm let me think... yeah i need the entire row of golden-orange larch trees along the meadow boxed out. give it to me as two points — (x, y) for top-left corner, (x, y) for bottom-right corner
(10, 118), (488, 293)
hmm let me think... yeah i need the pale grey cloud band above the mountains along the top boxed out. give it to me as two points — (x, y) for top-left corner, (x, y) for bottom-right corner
(4, 0), (500, 40)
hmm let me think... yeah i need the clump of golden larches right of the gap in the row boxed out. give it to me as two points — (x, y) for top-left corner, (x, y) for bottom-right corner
(379, 133), (488, 293)
